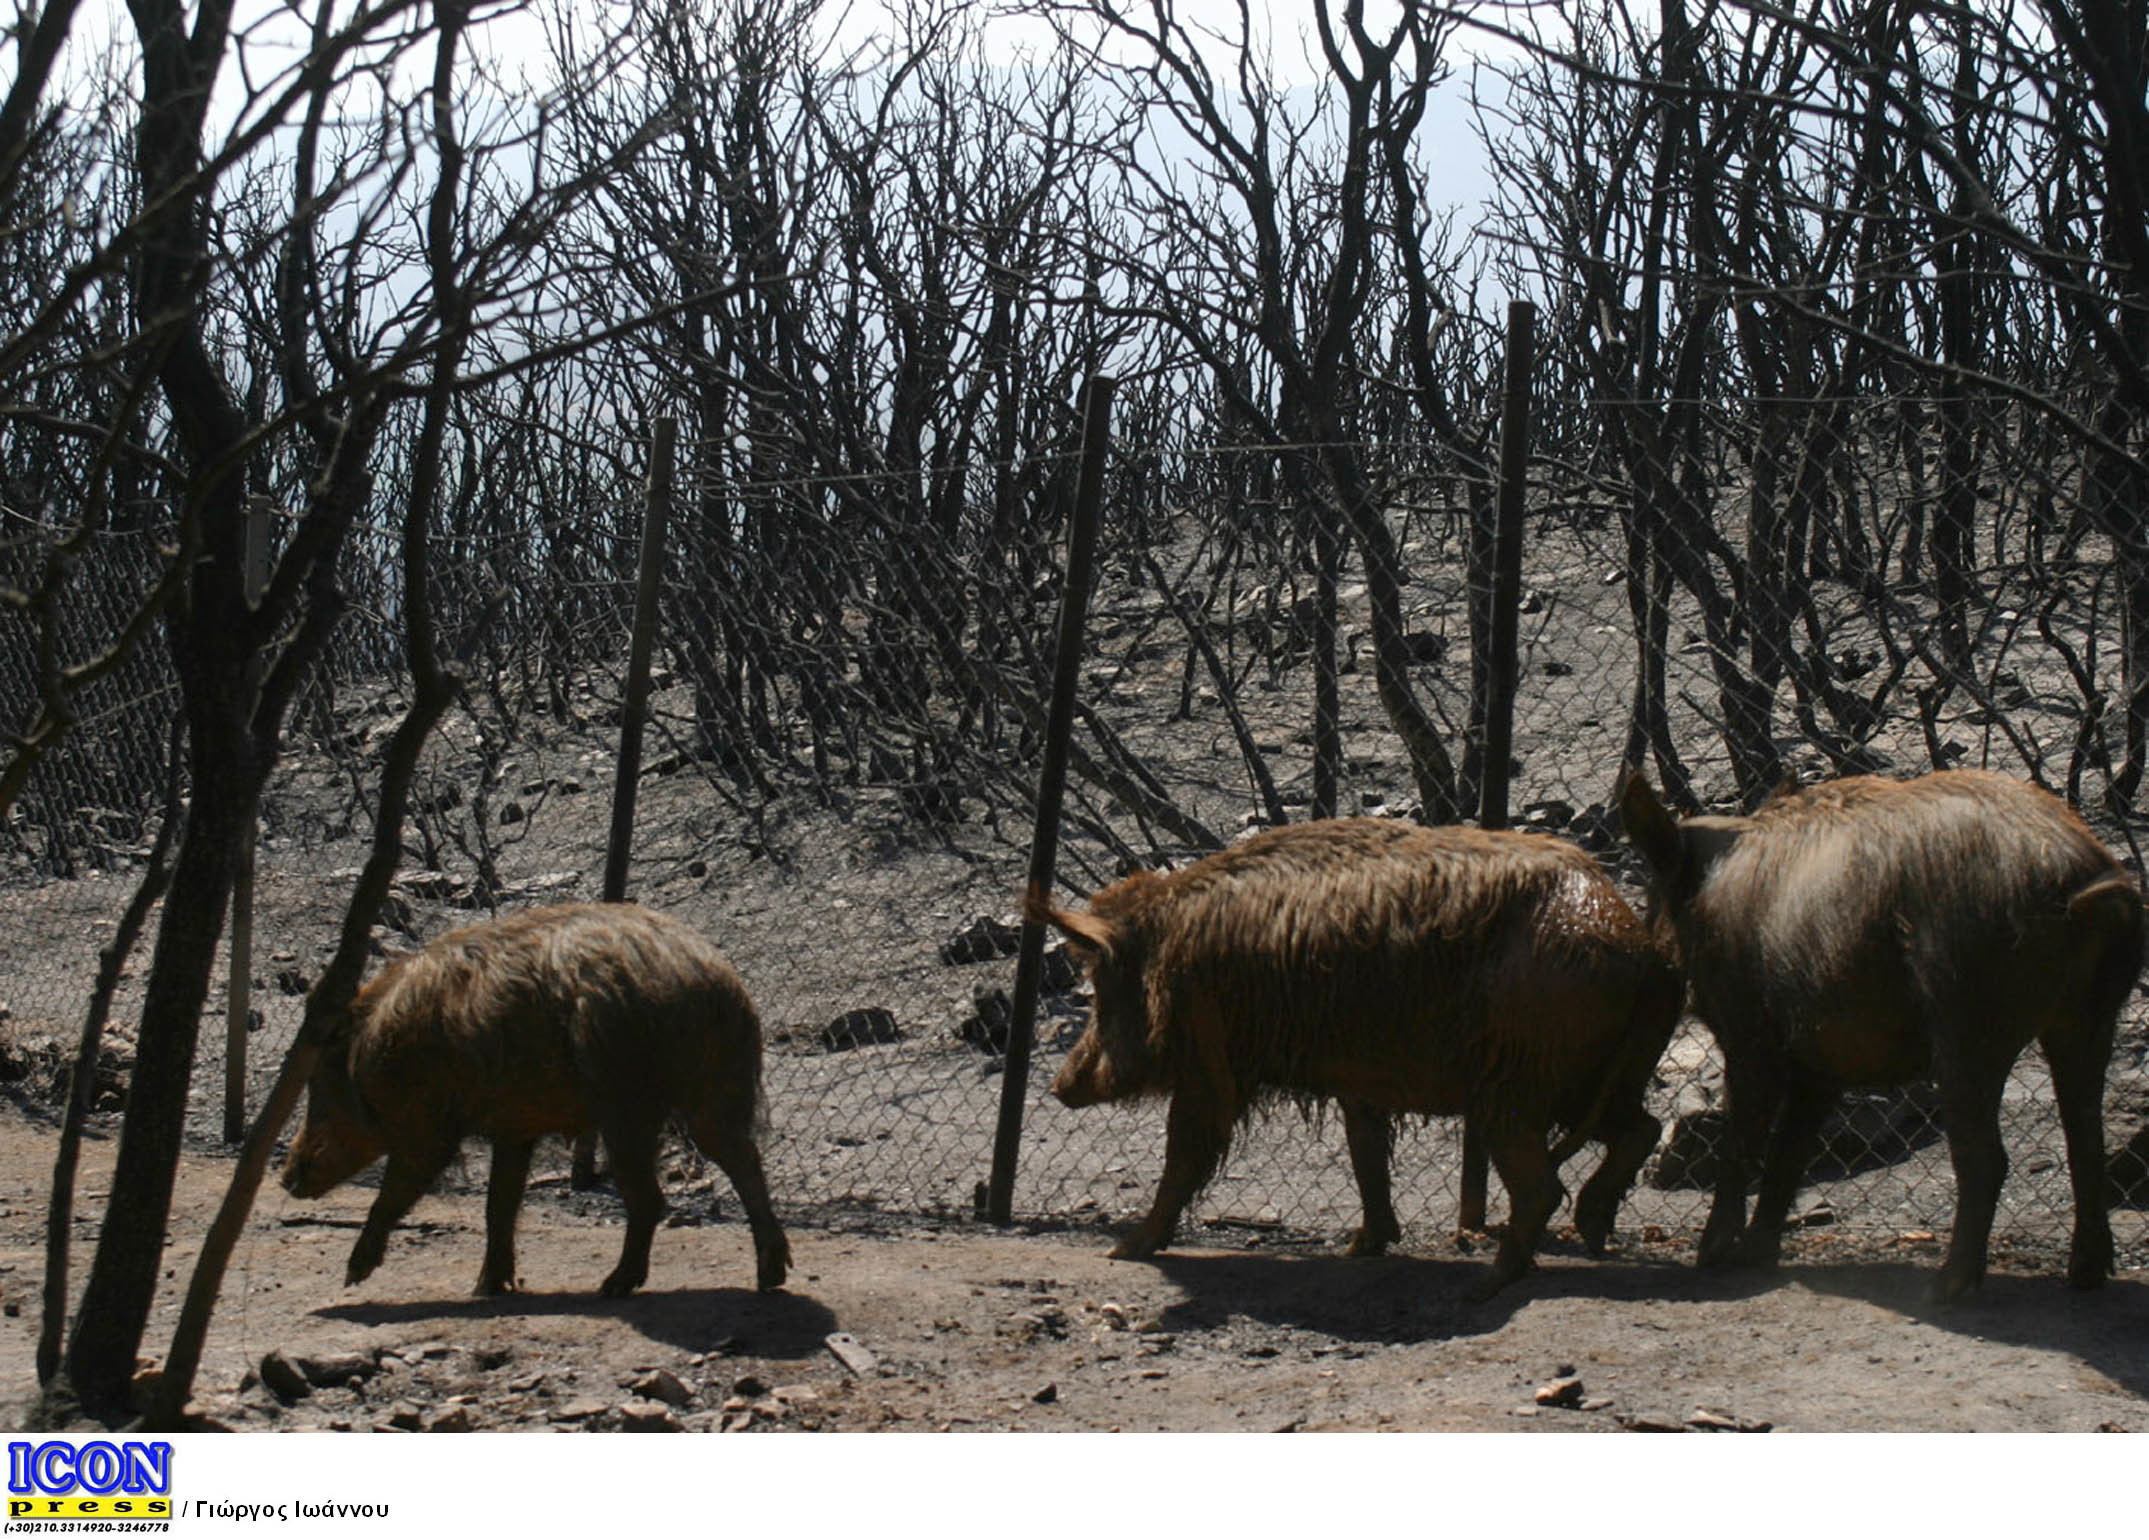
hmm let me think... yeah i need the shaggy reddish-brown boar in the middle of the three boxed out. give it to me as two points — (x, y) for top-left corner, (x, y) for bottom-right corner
(1029, 818), (1681, 1293)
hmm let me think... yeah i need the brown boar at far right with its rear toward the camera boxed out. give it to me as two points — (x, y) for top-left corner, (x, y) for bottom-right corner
(1620, 771), (2143, 1299)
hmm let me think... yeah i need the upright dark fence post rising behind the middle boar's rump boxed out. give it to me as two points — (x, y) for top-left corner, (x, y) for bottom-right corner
(1455, 299), (1537, 1231)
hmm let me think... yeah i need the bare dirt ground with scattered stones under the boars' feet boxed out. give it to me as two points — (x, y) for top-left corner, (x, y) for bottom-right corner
(0, 1110), (2149, 1433)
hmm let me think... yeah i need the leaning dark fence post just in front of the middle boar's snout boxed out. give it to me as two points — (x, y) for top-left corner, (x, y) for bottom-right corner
(984, 374), (1117, 1224)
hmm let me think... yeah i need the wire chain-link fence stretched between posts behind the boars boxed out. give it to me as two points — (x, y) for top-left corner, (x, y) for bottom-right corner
(0, 393), (2149, 1259)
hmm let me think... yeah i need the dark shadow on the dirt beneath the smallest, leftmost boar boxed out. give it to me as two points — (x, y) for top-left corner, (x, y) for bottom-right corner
(314, 1289), (836, 1357)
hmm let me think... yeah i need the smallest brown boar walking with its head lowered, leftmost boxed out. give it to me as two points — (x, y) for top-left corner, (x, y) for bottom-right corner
(284, 904), (791, 1295)
